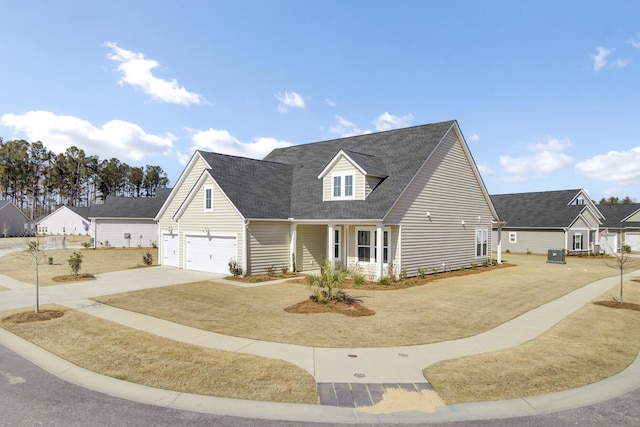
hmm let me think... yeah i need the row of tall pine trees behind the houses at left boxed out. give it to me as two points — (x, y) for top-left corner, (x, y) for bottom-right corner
(0, 137), (169, 219)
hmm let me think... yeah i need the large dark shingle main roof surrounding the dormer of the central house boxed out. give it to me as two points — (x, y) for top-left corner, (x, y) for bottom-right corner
(264, 121), (455, 219)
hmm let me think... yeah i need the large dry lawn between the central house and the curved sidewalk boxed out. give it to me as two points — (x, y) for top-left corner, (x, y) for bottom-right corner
(96, 254), (616, 347)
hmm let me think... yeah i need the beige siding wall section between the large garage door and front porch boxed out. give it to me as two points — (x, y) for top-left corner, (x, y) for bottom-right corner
(247, 221), (291, 275)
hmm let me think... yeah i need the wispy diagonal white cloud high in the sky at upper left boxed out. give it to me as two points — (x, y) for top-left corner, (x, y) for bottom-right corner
(105, 42), (204, 105)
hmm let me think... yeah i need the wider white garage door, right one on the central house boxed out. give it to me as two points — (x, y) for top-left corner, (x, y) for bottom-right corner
(185, 236), (236, 274)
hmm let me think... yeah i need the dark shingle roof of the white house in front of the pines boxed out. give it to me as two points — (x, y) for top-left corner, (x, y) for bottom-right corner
(89, 189), (170, 218)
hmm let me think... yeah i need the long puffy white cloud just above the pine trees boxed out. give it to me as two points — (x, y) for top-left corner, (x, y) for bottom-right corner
(0, 111), (176, 161)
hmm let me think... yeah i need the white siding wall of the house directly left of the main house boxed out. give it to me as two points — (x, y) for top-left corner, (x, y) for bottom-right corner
(92, 218), (158, 248)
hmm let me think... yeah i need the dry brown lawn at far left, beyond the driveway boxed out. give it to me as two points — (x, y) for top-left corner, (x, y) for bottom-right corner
(0, 248), (158, 286)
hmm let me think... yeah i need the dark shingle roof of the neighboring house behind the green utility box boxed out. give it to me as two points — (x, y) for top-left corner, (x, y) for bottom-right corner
(491, 190), (585, 228)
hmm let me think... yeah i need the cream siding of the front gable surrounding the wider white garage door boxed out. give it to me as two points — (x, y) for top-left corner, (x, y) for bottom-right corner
(179, 179), (244, 265)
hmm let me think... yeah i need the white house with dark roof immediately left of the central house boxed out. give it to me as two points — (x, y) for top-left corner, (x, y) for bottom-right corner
(89, 188), (171, 248)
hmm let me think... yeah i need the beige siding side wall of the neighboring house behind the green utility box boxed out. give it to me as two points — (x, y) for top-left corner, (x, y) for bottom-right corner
(492, 229), (571, 255)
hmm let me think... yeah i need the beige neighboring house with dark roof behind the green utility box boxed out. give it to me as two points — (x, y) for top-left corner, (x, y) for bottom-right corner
(491, 190), (604, 254)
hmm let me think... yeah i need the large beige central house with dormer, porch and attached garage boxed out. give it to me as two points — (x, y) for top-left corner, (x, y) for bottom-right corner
(156, 121), (497, 279)
